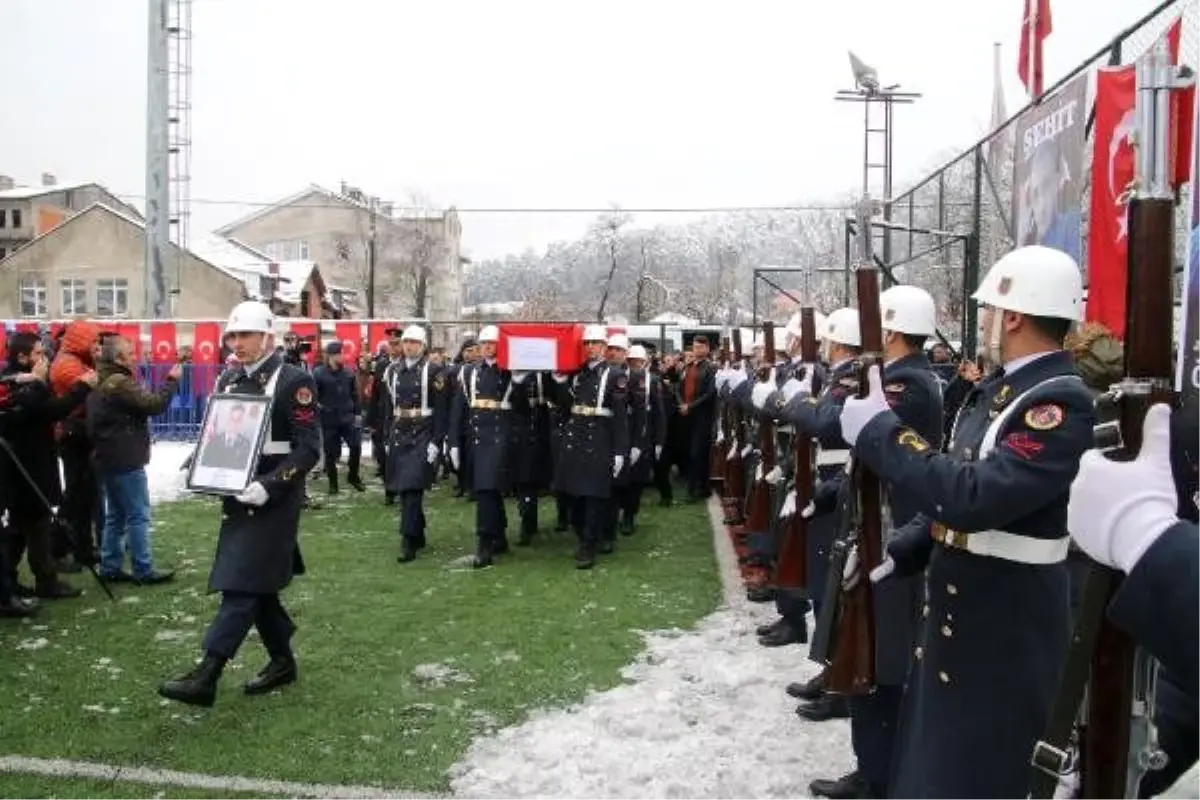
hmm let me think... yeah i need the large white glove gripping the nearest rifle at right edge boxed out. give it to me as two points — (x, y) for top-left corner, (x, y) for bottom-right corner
(1067, 404), (1178, 572)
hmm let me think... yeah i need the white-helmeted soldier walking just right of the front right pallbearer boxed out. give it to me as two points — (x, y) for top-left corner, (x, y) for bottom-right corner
(619, 344), (667, 536)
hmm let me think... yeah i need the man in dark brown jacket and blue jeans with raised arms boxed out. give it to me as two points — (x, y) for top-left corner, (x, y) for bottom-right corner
(86, 337), (182, 584)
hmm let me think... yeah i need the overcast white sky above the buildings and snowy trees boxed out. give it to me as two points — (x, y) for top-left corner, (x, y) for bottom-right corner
(0, 0), (1180, 258)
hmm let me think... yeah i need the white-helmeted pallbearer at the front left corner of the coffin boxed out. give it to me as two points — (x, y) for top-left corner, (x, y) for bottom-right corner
(450, 325), (512, 569)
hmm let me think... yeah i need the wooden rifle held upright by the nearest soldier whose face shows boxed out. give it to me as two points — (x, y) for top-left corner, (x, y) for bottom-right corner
(810, 198), (883, 694)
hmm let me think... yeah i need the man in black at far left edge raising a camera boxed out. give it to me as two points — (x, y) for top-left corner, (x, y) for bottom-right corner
(0, 333), (96, 600)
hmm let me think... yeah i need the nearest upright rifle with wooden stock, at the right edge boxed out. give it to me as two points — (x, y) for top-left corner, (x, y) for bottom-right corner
(1030, 43), (1181, 800)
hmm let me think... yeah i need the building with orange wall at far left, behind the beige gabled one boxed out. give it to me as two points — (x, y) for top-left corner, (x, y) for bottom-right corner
(0, 173), (142, 261)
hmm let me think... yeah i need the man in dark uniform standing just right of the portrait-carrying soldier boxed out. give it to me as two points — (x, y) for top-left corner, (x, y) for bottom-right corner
(312, 342), (367, 494)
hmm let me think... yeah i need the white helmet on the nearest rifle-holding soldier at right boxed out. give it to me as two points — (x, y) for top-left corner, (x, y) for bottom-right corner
(971, 245), (1084, 320)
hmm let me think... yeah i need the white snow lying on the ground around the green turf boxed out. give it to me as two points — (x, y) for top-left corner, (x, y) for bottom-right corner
(148, 443), (1200, 800)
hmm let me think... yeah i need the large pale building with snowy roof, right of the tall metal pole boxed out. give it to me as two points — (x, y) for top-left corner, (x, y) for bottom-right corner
(216, 185), (462, 338)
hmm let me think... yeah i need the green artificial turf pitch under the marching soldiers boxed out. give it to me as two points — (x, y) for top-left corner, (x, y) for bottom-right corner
(0, 485), (720, 798)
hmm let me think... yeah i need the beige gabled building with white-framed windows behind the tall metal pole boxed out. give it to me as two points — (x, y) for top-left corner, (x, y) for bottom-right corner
(0, 203), (248, 319)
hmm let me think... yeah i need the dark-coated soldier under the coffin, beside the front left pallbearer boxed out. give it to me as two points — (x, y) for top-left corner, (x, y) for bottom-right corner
(511, 372), (552, 546)
